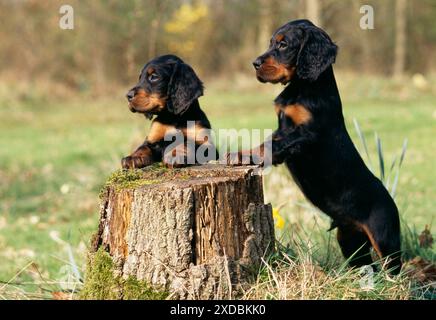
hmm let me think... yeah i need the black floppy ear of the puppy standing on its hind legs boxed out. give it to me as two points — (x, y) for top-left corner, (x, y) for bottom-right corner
(297, 26), (338, 81)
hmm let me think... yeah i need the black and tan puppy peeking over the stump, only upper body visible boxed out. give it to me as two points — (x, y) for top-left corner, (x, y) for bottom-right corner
(121, 55), (216, 169)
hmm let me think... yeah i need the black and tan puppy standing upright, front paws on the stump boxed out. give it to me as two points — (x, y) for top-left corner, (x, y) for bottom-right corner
(230, 20), (401, 272)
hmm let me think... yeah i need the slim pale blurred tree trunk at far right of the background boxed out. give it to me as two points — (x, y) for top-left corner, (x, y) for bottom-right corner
(393, 0), (407, 78)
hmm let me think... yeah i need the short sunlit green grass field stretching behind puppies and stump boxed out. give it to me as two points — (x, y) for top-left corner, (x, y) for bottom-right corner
(0, 75), (436, 298)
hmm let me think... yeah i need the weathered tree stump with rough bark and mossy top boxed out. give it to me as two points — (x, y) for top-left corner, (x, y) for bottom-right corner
(88, 164), (275, 299)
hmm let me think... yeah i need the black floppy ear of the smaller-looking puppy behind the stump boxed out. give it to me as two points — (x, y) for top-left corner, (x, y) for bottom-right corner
(167, 62), (203, 114)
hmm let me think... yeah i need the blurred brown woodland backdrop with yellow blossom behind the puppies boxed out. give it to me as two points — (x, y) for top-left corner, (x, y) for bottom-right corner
(0, 0), (436, 90)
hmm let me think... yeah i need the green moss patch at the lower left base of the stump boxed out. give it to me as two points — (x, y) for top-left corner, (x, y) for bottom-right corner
(79, 248), (168, 300)
